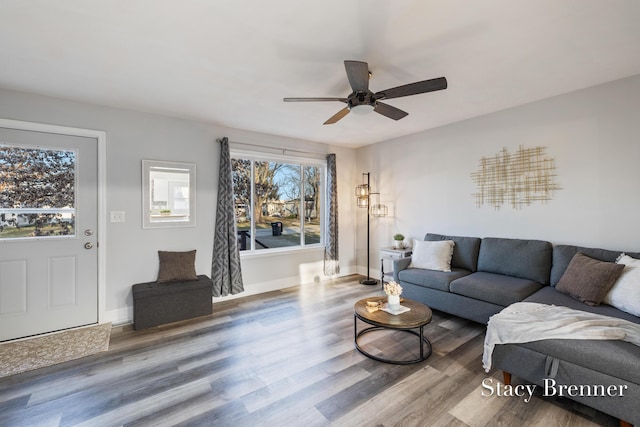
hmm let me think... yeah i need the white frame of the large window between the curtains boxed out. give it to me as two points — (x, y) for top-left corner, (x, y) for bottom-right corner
(229, 148), (327, 257)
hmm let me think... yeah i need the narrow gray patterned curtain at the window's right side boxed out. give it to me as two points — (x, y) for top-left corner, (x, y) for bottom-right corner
(324, 154), (340, 276)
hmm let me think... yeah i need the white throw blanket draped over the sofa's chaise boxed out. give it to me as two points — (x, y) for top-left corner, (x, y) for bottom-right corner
(482, 302), (640, 372)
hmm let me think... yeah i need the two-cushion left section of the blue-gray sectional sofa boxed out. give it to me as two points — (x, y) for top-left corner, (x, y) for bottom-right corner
(393, 233), (552, 324)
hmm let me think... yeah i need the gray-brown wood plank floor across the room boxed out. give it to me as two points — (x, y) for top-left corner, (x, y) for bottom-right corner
(0, 276), (617, 427)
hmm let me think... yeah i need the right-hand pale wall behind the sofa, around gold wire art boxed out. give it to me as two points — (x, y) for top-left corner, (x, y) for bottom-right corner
(357, 76), (640, 277)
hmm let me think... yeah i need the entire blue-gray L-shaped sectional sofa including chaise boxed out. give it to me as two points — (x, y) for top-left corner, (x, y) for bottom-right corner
(393, 233), (640, 425)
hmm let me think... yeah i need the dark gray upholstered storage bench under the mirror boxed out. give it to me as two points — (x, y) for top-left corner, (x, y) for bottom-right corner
(132, 275), (213, 330)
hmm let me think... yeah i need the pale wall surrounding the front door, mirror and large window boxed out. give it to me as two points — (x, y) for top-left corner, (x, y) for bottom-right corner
(0, 89), (355, 323)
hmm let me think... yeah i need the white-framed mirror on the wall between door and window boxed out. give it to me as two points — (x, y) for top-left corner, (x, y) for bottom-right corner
(142, 160), (196, 228)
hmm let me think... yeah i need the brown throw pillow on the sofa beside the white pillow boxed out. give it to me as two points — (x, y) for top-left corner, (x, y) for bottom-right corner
(556, 253), (624, 306)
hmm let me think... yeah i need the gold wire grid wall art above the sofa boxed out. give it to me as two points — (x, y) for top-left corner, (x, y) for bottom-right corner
(471, 145), (561, 210)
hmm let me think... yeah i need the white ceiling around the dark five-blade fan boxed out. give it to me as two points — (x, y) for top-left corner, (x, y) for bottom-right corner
(0, 0), (640, 147)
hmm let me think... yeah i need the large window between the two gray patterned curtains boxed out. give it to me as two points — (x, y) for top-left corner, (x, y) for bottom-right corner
(231, 153), (326, 252)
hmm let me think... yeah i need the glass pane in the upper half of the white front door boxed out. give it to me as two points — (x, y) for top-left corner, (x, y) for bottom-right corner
(0, 145), (76, 239)
